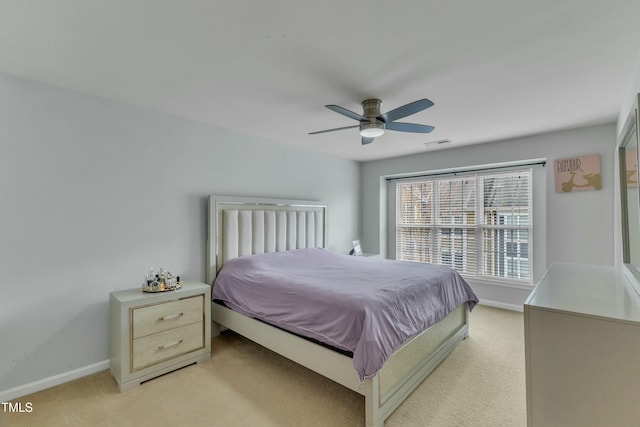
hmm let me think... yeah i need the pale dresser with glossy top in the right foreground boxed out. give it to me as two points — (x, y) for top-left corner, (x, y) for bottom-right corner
(524, 264), (640, 427)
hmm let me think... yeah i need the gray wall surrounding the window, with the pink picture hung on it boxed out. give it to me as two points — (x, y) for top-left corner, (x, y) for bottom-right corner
(361, 123), (616, 308)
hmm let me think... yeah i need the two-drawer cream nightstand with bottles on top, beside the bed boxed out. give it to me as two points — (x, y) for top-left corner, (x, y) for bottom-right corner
(109, 282), (211, 391)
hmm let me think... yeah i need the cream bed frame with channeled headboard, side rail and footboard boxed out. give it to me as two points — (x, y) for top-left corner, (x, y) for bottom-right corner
(207, 195), (469, 427)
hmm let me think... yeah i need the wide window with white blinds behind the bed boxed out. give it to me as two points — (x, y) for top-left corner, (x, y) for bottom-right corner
(396, 169), (533, 283)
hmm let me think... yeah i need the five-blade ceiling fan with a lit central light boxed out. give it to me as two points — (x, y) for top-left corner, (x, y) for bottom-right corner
(309, 98), (435, 145)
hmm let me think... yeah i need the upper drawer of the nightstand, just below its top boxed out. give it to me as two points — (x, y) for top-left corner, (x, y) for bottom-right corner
(132, 295), (204, 339)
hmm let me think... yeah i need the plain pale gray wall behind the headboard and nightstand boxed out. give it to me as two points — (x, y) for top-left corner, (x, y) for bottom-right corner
(0, 74), (360, 400)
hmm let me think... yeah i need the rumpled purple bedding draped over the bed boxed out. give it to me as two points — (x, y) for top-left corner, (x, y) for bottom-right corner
(212, 249), (478, 380)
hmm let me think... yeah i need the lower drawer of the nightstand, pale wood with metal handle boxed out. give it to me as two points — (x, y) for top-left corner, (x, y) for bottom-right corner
(131, 322), (204, 371)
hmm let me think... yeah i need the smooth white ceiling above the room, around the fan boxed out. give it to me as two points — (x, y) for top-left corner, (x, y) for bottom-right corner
(0, 0), (640, 160)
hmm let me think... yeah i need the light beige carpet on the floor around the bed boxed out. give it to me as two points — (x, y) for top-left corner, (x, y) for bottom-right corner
(0, 306), (526, 427)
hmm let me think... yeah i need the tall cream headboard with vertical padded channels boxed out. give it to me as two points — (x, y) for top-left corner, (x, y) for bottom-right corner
(207, 195), (327, 284)
